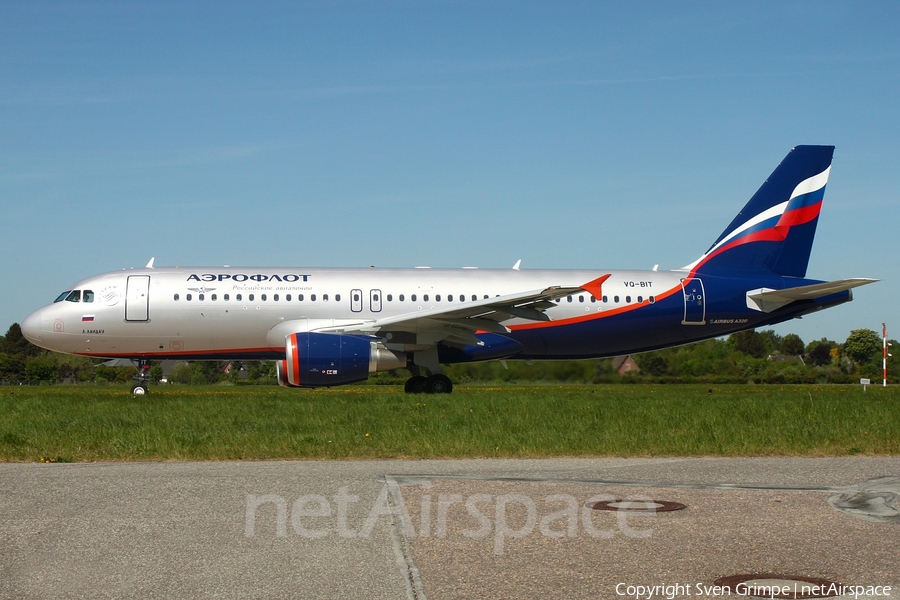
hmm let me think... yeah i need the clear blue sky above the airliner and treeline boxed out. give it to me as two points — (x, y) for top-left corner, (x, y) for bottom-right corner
(0, 1), (900, 342)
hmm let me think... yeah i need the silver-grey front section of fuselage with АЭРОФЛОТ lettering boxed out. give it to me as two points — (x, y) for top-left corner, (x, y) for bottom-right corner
(23, 267), (684, 358)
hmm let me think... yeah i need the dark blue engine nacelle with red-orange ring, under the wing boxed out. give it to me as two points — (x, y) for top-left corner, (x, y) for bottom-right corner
(275, 333), (406, 387)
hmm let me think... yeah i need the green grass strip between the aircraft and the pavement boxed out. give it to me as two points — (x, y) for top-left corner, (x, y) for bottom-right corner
(0, 385), (900, 462)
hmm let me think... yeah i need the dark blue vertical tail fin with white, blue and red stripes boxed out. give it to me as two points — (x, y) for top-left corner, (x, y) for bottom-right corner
(685, 146), (834, 277)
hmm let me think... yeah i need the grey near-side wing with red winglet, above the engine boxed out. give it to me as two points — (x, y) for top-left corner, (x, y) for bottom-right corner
(316, 275), (609, 346)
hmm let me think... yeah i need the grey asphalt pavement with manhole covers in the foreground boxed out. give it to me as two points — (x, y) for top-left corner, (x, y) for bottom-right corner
(0, 457), (900, 600)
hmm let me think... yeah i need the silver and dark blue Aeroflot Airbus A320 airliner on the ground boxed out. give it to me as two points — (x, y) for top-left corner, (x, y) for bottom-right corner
(22, 146), (876, 395)
